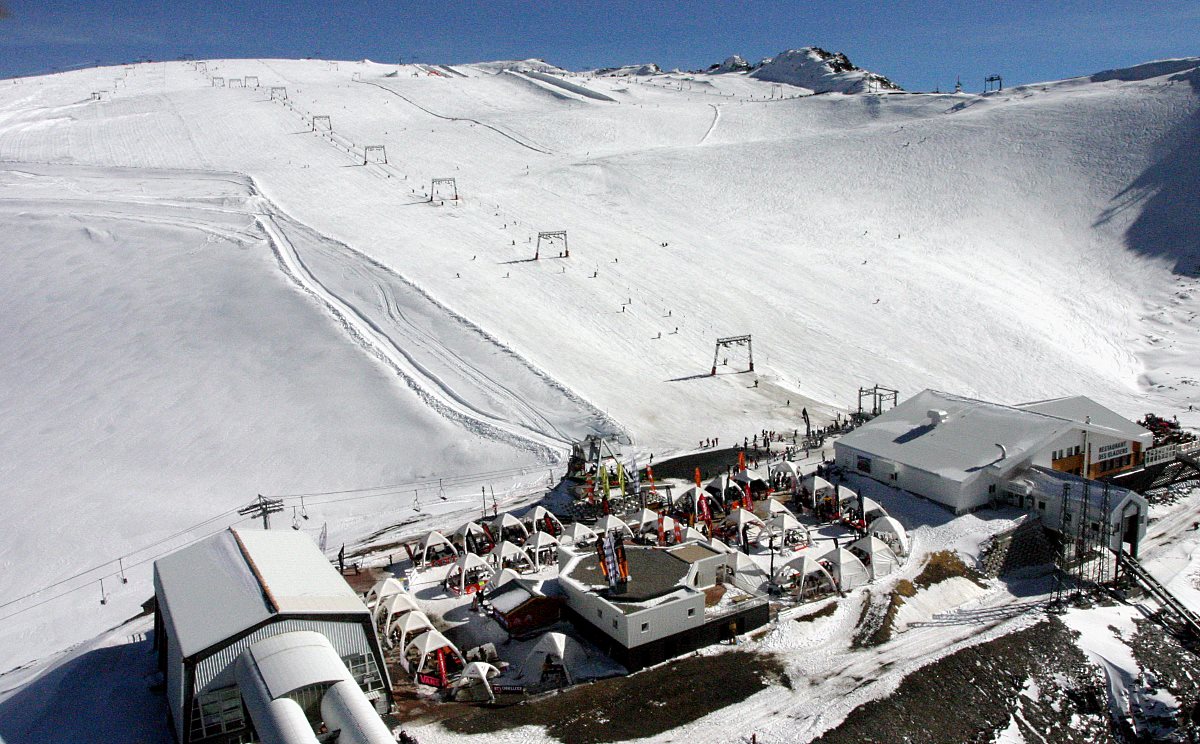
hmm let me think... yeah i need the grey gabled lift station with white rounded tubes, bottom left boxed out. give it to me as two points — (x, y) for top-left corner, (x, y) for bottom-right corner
(154, 529), (394, 744)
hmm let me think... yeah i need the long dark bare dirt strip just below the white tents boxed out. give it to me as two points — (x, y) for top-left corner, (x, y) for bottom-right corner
(443, 650), (786, 744)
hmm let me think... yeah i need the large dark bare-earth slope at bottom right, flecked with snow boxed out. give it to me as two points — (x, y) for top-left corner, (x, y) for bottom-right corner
(817, 618), (1115, 744)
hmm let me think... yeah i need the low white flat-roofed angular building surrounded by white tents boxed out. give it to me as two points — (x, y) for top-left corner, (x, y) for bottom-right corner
(558, 542), (769, 672)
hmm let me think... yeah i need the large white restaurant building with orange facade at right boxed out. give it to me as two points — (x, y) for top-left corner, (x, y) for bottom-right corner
(834, 390), (1152, 514)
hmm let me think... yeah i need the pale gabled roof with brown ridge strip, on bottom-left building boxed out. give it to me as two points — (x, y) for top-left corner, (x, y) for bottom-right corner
(154, 528), (368, 656)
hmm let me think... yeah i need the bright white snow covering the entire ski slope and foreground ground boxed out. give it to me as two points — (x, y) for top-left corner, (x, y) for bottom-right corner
(0, 49), (1200, 743)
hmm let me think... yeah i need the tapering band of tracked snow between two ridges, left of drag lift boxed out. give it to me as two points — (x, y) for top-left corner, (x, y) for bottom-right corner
(256, 204), (619, 462)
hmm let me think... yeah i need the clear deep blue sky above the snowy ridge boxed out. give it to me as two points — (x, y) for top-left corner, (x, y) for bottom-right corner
(0, 0), (1200, 90)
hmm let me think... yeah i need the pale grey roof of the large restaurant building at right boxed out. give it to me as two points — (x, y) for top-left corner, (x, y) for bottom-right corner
(834, 390), (1152, 482)
